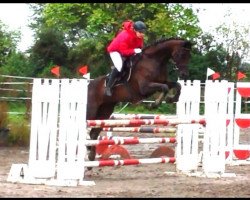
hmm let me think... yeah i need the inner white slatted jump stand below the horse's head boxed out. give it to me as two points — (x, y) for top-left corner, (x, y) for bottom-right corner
(176, 80), (203, 174)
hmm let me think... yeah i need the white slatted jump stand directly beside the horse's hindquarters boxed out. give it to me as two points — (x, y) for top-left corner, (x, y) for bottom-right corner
(53, 79), (91, 185)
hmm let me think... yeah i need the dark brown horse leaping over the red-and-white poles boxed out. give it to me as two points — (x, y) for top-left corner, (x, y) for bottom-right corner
(86, 38), (193, 167)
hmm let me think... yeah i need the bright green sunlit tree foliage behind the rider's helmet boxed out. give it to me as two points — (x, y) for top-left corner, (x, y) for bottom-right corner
(37, 3), (200, 44)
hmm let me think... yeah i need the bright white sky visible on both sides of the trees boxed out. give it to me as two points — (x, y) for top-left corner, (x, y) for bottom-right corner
(0, 3), (250, 55)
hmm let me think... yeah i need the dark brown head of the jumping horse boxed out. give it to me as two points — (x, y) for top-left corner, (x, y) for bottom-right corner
(171, 40), (192, 80)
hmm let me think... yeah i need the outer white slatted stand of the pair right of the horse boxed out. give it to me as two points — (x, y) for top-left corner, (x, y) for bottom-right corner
(202, 80), (228, 176)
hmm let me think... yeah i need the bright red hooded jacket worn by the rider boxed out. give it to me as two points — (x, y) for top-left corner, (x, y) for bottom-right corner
(107, 21), (144, 56)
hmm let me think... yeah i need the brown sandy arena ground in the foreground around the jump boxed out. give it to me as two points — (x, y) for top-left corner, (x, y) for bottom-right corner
(0, 129), (250, 198)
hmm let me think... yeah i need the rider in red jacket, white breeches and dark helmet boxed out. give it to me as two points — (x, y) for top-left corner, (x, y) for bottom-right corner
(105, 20), (146, 96)
